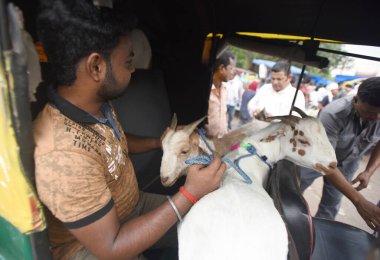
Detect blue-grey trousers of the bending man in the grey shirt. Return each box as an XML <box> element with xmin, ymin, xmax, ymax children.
<box><xmin>300</xmin><ymin>160</ymin><xmax>360</xmax><ymax>220</ymax></box>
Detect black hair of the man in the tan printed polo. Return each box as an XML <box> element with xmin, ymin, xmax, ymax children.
<box><xmin>37</xmin><ymin>0</ymin><xmax>133</xmax><ymax>85</ymax></box>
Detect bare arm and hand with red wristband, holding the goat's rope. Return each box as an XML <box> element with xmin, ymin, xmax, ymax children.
<box><xmin>70</xmin><ymin>156</ymin><xmax>226</xmax><ymax>259</ymax></box>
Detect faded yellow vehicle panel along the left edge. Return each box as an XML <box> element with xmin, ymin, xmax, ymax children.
<box><xmin>0</xmin><ymin>52</ymin><xmax>46</xmax><ymax>234</ymax></box>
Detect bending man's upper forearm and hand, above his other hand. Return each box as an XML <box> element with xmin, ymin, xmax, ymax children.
<box><xmin>352</xmin><ymin>142</ymin><xmax>380</xmax><ymax>191</ymax></box>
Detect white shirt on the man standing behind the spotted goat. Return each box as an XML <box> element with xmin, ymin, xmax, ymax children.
<box><xmin>248</xmin><ymin>84</ymin><xmax>305</xmax><ymax>116</ymax></box>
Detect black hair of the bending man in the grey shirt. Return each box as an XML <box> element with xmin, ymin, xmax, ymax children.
<box><xmin>357</xmin><ymin>77</ymin><xmax>380</xmax><ymax>107</ymax></box>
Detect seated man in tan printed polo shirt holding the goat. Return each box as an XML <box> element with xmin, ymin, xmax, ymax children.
<box><xmin>33</xmin><ymin>0</ymin><xmax>226</xmax><ymax>260</ymax></box>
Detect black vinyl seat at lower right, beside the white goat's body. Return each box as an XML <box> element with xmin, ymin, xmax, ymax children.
<box><xmin>267</xmin><ymin>160</ymin><xmax>375</xmax><ymax>260</ymax></box>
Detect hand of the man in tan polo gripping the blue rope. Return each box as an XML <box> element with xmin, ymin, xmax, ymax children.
<box><xmin>184</xmin><ymin>154</ymin><xmax>227</xmax><ymax>199</ymax></box>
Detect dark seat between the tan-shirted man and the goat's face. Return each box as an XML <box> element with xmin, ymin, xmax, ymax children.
<box><xmin>112</xmin><ymin>69</ymin><xmax>182</xmax><ymax>194</ymax></box>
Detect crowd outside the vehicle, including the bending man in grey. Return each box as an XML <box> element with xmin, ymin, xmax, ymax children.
<box><xmin>208</xmin><ymin>53</ymin><xmax>380</xmax><ymax>231</ymax></box>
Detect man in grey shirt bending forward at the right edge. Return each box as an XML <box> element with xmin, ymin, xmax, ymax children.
<box><xmin>300</xmin><ymin>77</ymin><xmax>380</xmax><ymax>228</ymax></box>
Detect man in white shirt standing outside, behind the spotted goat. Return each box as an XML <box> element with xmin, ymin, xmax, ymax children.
<box><xmin>248</xmin><ymin>61</ymin><xmax>305</xmax><ymax>117</ymax></box>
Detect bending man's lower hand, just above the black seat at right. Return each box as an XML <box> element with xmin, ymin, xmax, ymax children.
<box><xmin>355</xmin><ymin>197</ymin><xmax>380</xmax><ymax>231</ymax></box>
